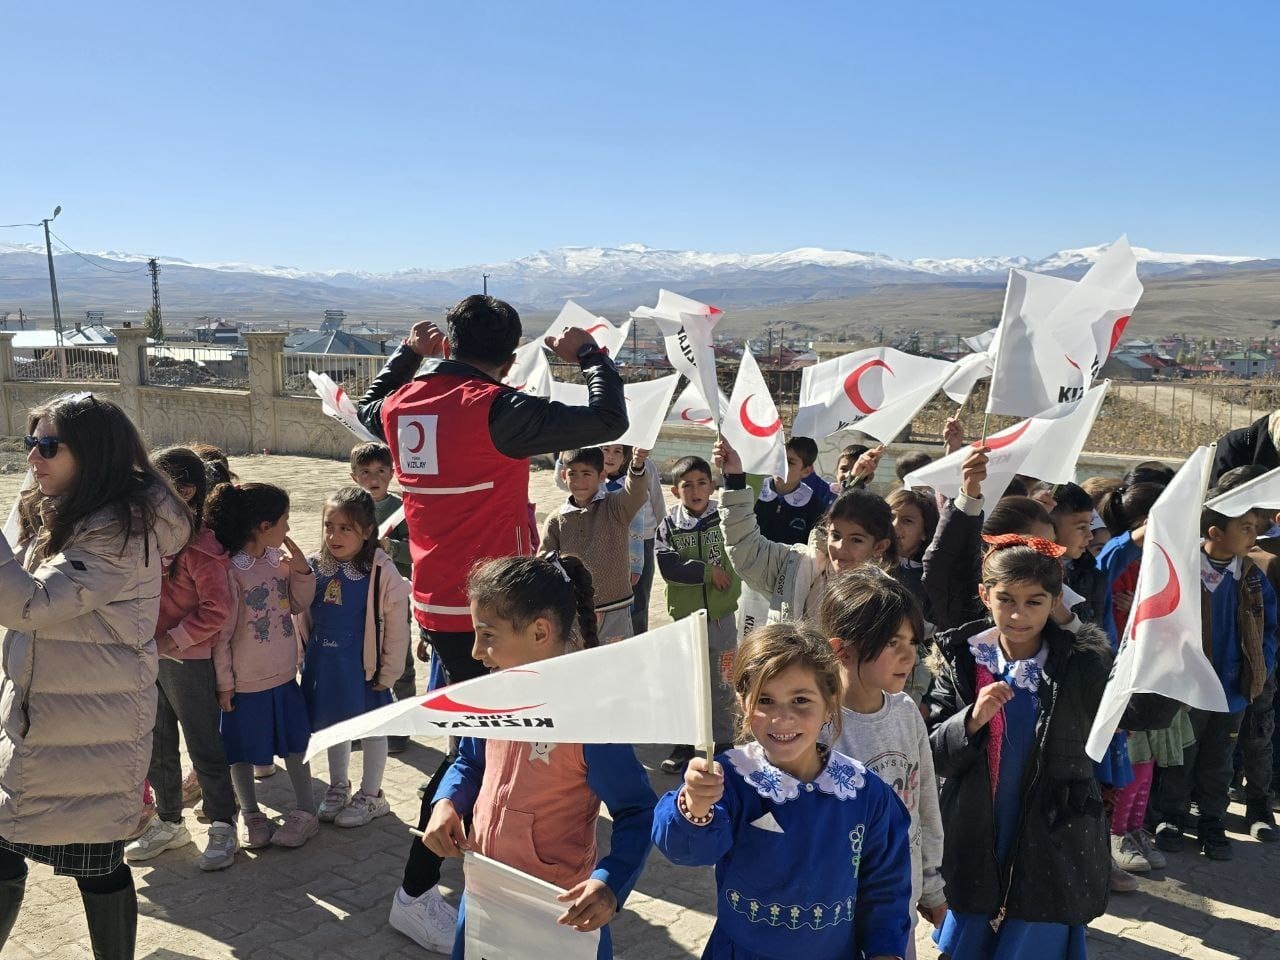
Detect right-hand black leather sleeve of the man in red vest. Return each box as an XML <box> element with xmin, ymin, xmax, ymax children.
<box><xmin>486</xmin><ymin>353</ymin><xmax>628</xmax><ymax>460</ymax></box>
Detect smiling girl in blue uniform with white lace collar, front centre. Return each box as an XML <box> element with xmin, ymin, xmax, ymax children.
<box><xmin>653</xmin><ymin>622</ymin><xmax>911</xmax><ymax>960</ymax></box>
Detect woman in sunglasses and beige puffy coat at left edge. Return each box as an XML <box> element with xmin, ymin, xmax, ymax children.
<box><xmin>0</xmin><ymin>393</ymin><xmax>193</xmax><ymax>960</ymax></box>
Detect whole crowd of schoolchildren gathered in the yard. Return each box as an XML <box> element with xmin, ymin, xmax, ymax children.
<box><xmin>102</xmin><ymin>424</ymin><xmax>1280</xmax><ymax>960</ymax></box>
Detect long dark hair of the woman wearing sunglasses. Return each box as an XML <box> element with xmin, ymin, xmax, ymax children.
<box><xmin>18</xmin><ymin>393</ymin><xmax>195</xmax><ymax>557</ymax></box>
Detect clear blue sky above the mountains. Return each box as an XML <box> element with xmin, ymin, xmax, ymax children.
<box><xmin>0</xmin><ymin>0</ymin><xmax>1280</xmax><ymax>270</ymax></box>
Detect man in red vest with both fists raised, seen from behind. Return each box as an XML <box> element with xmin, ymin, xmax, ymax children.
<box><xmin>358</xmin><ymin>296</ymin><xmax>627</xmax><ymax>954</ymax></box>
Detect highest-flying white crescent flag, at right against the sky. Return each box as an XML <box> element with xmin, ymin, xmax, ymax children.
<box><xmin>987</xmin><ymin>237</ymin><xmax>1142</xmax><ymax>416</ymax></box>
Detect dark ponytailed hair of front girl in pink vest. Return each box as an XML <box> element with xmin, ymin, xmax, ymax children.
<box><xmin>467</xmin><ymin>554</ymin><xmax>600</xmax><ymax>648</ymax></box>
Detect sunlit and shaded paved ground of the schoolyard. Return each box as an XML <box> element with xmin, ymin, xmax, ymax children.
<box><xmin>0</xmin><ymin>457</ymin><xmax>1280</xmax><ymax>960</ymax></box>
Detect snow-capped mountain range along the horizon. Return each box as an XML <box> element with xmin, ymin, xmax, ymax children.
<box><xmin>0</xmin><ymin>243</ymin><xmax>1265</xmax><ymax>312</ymax></box>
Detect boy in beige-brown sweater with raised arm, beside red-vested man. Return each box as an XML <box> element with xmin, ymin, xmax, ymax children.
<box><xmin>540</xmin><ymin>447</ymin><xmax>649</xmax><ymax>644</ymax></box>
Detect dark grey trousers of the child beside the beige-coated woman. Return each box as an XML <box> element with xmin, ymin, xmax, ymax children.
<box><xmin>147</xmin><ymin>658</ymin><xmax>236</xmax><ymax>823</ymax></box>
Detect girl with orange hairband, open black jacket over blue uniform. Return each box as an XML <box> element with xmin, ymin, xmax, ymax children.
<box><xmin>924</xmin><ymin>534</ymin><xmax>1111</xmax><ymax>960</ymax></box>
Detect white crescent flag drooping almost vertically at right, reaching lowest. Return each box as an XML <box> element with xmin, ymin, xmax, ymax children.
<box><xmin>1084</xmin><ymin>447</ymin><xmax>1226</xmax><ymax>760</ymax></box>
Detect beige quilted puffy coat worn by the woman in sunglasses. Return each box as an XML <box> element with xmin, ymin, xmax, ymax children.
<box><xmin>0</xmin><ymin>494</ymin><xmax>191</xmax><ymax>844</ymax></box>
